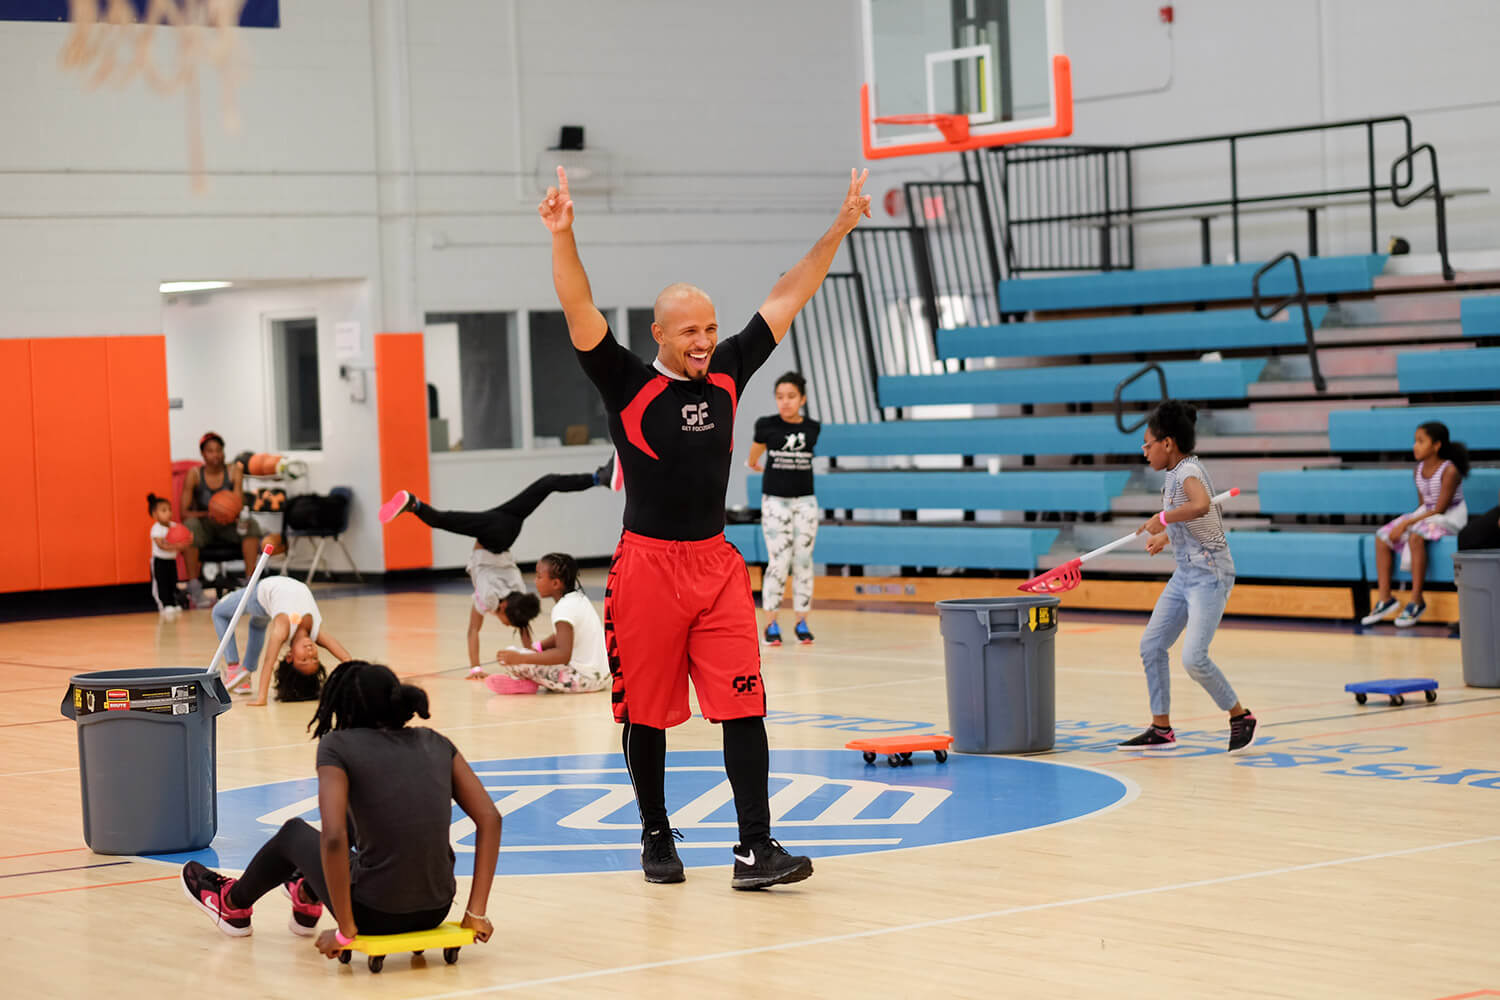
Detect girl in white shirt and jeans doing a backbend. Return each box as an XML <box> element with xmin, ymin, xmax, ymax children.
<box><xmin>213</xmin><ymin>576</ymin><xmax>350</xmax><ymax>705</ymax></box>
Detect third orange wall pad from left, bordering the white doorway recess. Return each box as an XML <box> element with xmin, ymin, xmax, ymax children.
<box><xmin>104</xmin><ymin>337</ymin><xmax>173</xmax><ymax>583</ymax></box>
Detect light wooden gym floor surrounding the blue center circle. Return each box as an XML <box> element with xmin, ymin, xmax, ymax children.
<box><xmin>0</xmin><ymin>574</ymin><xmax>1500</xmax><ymax>1000</ymax></box>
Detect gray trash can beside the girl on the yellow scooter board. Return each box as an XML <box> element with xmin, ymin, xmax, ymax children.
<box><xmin>62</xmin><ymin>667</ymin><xmax>230</xmax><ymax>855</ymax></box>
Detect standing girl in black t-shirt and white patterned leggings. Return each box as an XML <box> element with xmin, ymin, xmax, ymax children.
<box><xmin>746</xmin><ymin>372</ymin><xmax>821</xmax><ymax>646</ymax></box>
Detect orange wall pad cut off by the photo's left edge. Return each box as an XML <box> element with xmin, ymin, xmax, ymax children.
<box><xmin>0</xmin><ymin>340</ymin><xmax>42</xmax><ymax>592</ymax></box>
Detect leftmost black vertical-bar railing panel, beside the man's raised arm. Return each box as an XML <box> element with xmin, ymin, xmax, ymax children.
<box><xmin>791</xmin><ymin>274</ymin><xmax>884</xmax><ymax>423</ymax></box>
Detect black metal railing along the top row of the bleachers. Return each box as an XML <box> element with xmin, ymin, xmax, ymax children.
<box><xmin>978</xmin><ymin>115</ymin><xmax>1448</xmax><ymax>276</ymax></box>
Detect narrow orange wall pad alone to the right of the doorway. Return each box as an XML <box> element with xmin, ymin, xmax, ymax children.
<box><xmin>375</xmin><ymin>333</ymin><xmax>432</xmax><ymax>570</ymax></box>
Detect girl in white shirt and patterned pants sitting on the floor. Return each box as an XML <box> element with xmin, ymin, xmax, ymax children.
<box><xmin>495</xmin><ymin>552</ymin><xmax>609</xmax><ymax>694</ymax></box>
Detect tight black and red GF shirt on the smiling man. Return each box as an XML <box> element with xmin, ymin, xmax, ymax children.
<box><xmin>578</xmin><ymin>313</ymin><xmax>776</xmax><ymax>541</ymax></box>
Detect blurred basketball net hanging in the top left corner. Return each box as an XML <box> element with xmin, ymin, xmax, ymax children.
<box><xmin>62</xmin><ymin>0</ymin><xmax>246</xmax><ymax>192</ymax></box>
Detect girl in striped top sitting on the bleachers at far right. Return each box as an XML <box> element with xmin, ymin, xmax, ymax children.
<box><xmin>1361</xmin><ymin>420</ymin><xmax>1469</xmax><ymax>628</ymax></box>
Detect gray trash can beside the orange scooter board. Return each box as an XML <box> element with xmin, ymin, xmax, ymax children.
<box><xmin>938</xmin><ymin>597</ymin><xmax>1059</xmax><ymax>754</ymax></box>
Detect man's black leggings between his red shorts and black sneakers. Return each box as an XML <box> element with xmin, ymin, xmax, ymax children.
<box><xmin>620</xmin><ymin>717</ymin><xmax>771</xmax><ymax>844</ymax></box>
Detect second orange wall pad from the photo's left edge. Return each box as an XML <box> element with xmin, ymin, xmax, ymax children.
<box><xmin>32</xmin><ymin>337</ymin><xmax>117</xmax><ymax>589</ymax></box>
